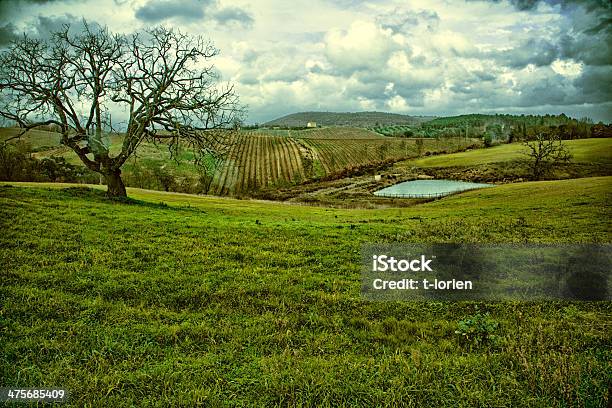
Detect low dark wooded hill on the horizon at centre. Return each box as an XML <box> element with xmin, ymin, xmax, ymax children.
<box><xmin>264</xmin><ymin>112</ymin><xmax>435</xmax><ymax>127</ymax></box>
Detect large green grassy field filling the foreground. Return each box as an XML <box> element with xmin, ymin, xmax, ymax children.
<box><xmin>0</xmin><ymin>177</ymin><xmax>612</xmax><ymax>407</ymax></box>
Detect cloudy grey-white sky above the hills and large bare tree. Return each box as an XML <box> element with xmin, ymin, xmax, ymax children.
<box><xmin>0</xmin><ymin>0</ymin><xmax>612</xmax><ymax>123</ymax></box>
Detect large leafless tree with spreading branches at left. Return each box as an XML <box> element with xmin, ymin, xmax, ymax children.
<box><xmin>0</xmin><ymin>21</ymin><xmax>243</xmax><ymax>197</ymax></box>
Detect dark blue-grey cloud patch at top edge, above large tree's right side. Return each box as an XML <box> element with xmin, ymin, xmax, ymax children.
<box><xmin>135</xmin><ymin>0</ymin><xmax>210</xmax><ymax>23</ymax></box>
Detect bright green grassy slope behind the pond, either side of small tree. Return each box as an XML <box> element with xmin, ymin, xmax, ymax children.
<box><xmin>406</xmin><ymin>138</ymin><xmax>612</xmax><ymax>167</ymax></box>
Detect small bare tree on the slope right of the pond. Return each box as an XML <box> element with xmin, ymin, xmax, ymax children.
<box><xmin>525</xmin><ymin>133</ymin><xmax>572</xmax><ymax>180</ymax></box>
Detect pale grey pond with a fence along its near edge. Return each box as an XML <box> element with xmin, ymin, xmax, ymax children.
<box><xmin>374</xmin><ymin>180</ymin><xmax>494</xmax><ymax>198</ymax></box>
